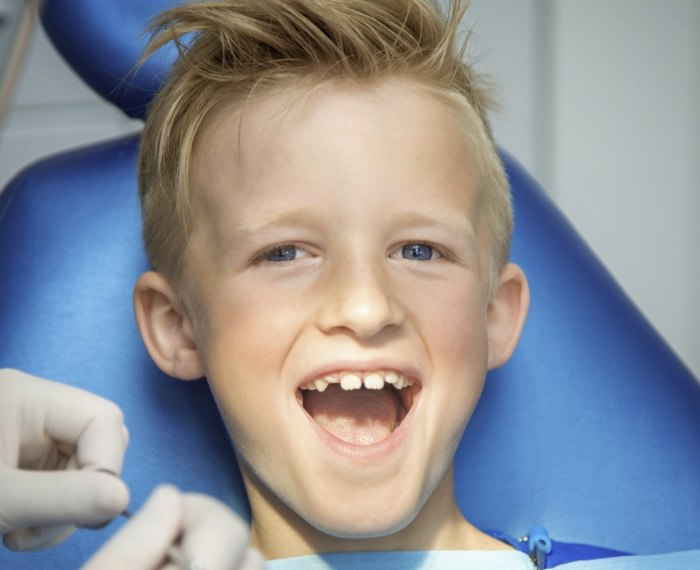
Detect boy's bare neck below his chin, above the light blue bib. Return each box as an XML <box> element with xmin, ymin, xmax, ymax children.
<box><xmin>248</xmin><ymin>470</ymin><xmax>510</xmax><ymax>560</ymax></box>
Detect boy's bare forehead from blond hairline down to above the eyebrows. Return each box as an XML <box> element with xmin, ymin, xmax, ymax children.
<box><xmin>189</xmin><ymin>80</ymin><xmax>486</xmax><ymax>235</ymax></box>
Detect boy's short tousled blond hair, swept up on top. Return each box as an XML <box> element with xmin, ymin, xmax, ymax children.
<box><xmin>139</xmin><ymin>0</ymin><xmax>512</xmax><ymax>285</ymax></box>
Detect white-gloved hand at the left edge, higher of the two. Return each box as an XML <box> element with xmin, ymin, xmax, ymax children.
<box><xmin>0</xmin><ymin>369</ymin><xmax>129</xmax><ymax>550</ymax></box>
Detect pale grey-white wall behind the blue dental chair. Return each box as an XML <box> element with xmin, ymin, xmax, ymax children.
<box><xmin>0</xmin><ymin>0</ymin><xmax>700</xmax><ymax>382</ymax></box>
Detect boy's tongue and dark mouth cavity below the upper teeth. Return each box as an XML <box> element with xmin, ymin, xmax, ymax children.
<box><xmin>304</xmin><ymin>384</ymin><xmax>399</xmax><ymax>445</ymax></box>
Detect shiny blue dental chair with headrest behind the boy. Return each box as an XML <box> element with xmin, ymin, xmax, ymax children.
<box><xmin>0</xmin><ymin>0</ymin><xmax>700</xmax><ymax>569</ymax></box>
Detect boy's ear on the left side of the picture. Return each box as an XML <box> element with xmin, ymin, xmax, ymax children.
<box><xmin>134</xmin><ymin>271</ymin><xmax>204</xmax><ymax>380</ymax></box>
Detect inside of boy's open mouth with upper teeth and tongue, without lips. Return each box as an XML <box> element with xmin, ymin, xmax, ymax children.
<box><xmin>298</xmin><ymin>370</ymin><xmax>420</xmax><ymax>445</ymax></box>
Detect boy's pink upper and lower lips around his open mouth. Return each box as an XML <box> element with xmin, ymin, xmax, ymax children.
<box><xmin>296</xmin><ymin>360</ymin><xmax>423</xmax><ymax>463</ymax></box>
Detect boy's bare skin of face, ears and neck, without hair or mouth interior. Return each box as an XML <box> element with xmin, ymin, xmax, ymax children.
<box><xmin>135</xmin><ymin>79</ymin><xmax>528</xmax><ymax>558</ymax></box>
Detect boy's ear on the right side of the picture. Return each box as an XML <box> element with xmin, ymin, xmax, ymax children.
<box><xmin>487</xmin><ymin>263</ymin><xmax>530</xmax><ymax>370</ymax></box>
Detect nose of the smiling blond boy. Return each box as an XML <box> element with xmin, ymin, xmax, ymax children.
<box><xmin>319</xmin><ymin>261</ymin><xmax>404</xmax><ymax>339</ymax></box>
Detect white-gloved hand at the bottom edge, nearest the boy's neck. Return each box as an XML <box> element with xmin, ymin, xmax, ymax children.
<box><xmin>83</xmin><ymin>486</ymin><xmax>264</xmax><ymax>570</ymax></box>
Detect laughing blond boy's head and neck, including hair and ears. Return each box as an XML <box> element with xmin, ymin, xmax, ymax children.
<box><xmin>130</xmin><ymin>0</ymin><xmax>612</xmax><ymax>560</ymax></box>
